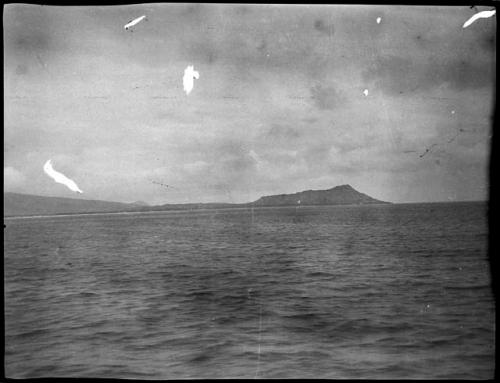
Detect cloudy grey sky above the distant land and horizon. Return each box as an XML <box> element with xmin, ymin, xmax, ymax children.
<box><xmin>4</xmin><ymin>4</ymin><xmax>496</xmax><ymax>204</ymax></box>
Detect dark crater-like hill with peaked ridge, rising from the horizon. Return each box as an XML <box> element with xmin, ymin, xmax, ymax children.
<box><xmin>253</xmin><ymin>185</ymin><xmax>389</xmax><ymax>206</ymax></box>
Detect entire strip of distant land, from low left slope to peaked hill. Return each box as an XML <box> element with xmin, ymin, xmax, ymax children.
<box><xmin>4</xmin><ymin>185</ymin><xmax>390</xmax><ymax>217</ymax></box>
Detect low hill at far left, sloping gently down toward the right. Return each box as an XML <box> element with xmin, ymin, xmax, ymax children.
<box><xmin>3</xmin><ymin>193</ymin><xmax>138</xmax><ymax>217</ymax></box>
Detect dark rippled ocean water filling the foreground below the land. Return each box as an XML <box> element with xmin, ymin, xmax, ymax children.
<box><xmin>4</xmin><ymin>203</ymin><xmax>495</xmax><ymax>379</ymax></box>
